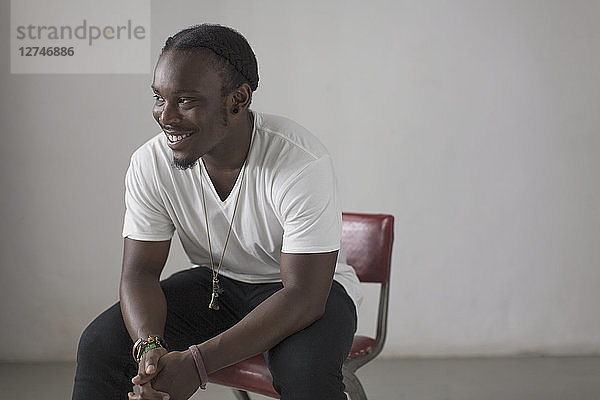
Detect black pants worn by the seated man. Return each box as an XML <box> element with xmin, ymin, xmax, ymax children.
<box><xmin>73</xmin><ymin>267</ymin><xmax>356</xmax><ymax>400</ymax></box>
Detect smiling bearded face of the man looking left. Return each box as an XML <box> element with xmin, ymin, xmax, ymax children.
<box><xmin>152</xmin><ymin>51</ymin><xmax>228</xmax><ymax>169</ymax></box>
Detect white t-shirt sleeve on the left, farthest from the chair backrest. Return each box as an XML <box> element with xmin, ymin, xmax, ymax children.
<box><xmin>123</xmin><ymin>153</ymin><xmax>175</xmax><ymax>241</ymax></box>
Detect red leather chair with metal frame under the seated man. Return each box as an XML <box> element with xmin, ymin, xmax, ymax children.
<box><xmin>208</xmin><ymin>213</ymin><xmax>394</xmax><ymax>400</ymax></box>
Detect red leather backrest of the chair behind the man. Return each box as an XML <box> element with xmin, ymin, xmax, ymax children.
<box><xmin>342</xmin><ymin>213</ymin><xmax>394</xmax><ymax>283</ymax></box>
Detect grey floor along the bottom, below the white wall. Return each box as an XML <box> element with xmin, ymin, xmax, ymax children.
<box><xmin>0</xmin><ymin>357</ymin><xmax>600</xmax><ymax>400</ymax></box>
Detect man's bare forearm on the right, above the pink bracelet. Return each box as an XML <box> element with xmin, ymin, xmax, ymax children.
<box><xmin>198</xmin><ymin>288</ymin><xmax>324</xmax><ymax>373</ymax></box>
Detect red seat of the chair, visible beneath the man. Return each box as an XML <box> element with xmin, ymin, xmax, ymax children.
<box><xmin>208</xmin><ymin>335</ymin><xmax>377</xmax><ymax>398</ymax></box>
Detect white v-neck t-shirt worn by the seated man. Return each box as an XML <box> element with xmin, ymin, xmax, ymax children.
<box><xmin>123</xmin><ymin>112</ymin><xmax>361</xmax><ymax>306</ymax></box>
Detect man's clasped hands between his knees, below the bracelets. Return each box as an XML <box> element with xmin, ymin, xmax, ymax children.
<box><xmin>128</xmin><ymin>348</ymin><xmax>200</xmax><ymax>400</ymax></box>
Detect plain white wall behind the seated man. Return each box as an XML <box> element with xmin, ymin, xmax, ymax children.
<box><xmin>0</xmin><ymin>0</ymin><xmax>600</xmax><ymax>360</ymax></box>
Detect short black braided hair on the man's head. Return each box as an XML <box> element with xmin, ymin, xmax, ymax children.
<box><xmin>161</xmin><ymin>24</ymin><xmax>258</xmax><ymax>95</ymax></box>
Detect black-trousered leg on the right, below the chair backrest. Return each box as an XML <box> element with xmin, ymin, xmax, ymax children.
<box><xmin>265</xmin><ymin>281</ymin><xmax>356</xmax><ymax>399</ymax></box>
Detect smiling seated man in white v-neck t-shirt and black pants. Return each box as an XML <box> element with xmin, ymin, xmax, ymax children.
<box><xmin>73</xmin><ymin>24</ymin><xmax>360</xmax><ymax>400</ymax></box>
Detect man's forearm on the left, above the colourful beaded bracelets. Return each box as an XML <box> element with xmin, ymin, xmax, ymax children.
<box><xmin>120</xmin><ymin>273</ymin><xmax>167</xmax><ymax>341</ymax></box>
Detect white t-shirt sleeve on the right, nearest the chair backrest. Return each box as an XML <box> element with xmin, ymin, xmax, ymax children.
<box><xmin>280</xmin><ymin>156</ymin><xmax>342</xmax><ymax>253</ymax></box>
